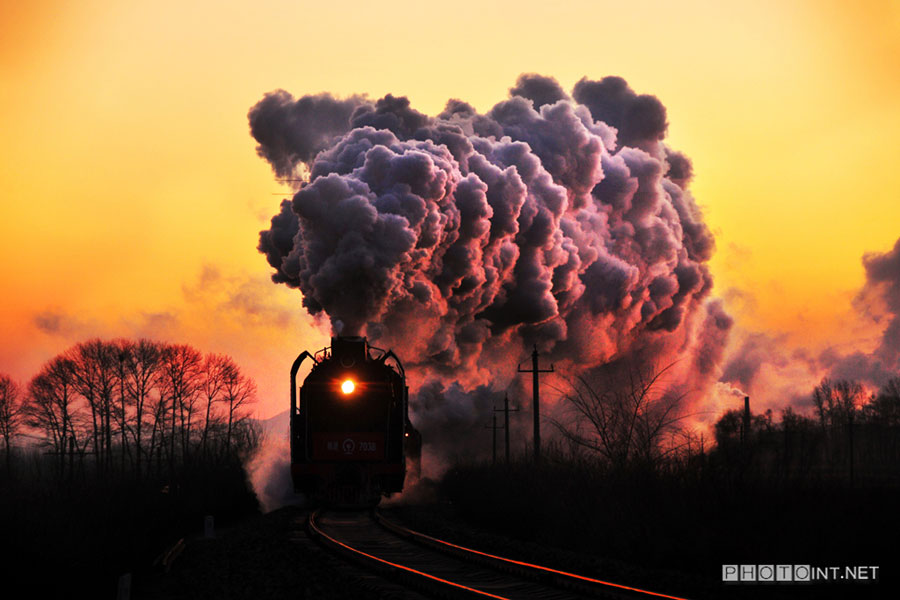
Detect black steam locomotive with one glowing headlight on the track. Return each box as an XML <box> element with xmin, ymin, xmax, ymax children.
<box><xmin>290</xmin><ymin>336</ymin><xmax>422</xmax><ymax>507</ymax></box>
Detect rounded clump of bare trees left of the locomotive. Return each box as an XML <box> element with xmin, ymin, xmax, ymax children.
<box><xmin>9</xmin><ymin>339</ymin><xmax>256</xmax><ymax>480</ymax></box>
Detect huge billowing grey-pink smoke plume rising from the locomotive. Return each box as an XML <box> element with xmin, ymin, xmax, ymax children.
<box><xmin>249</xmin><ymin>75</ymin><xmax>731</xmax><ymax>462</ymax></box>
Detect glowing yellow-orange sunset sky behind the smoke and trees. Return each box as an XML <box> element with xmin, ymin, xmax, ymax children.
<box><xmin>0</xmin><ymin>0</ymin><xmax>900</xmax><ymax>417</ymax></box>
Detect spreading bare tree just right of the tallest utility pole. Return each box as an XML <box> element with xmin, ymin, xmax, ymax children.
<box><xmin>555</xmin><ymin>355</ymin><xmax>686</xmax><ymax>467</ymax></box>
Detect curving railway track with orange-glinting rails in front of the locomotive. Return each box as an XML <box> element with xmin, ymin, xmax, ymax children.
<box><xmin>307</xmin><ymin>511</ymin><xmax>684</xmax><ymax>600</ymax></box>
